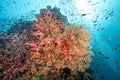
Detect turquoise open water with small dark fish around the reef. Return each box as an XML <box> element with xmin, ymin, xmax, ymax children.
<box><xmin>0</xmin><ymin>0</ymin><xmax>120</xmax><ymax>80</ymax></box>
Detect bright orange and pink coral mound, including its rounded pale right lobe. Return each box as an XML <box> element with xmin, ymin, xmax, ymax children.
<box><xmin>26</xmin><ymin>7</ymin><xmax>92</xmax><ymax>79</ymax></box>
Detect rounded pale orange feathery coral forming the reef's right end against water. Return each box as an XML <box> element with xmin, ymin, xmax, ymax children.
<box><xmin>55</xmin><ymin>25</ymin><xmax>92</xmax><ymax>73</ymax></box>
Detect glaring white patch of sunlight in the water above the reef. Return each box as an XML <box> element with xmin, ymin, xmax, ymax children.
<box><xmin>75</xmin><ymin>0</ymin><xmax>96</xmax><ymax>21</ymax></box>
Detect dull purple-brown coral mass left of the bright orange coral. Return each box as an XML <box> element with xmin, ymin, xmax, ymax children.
<box><xmin>0</xmin><ymin>21</ymin><xmax>33</xmax><ymax>80</ymax></box>
